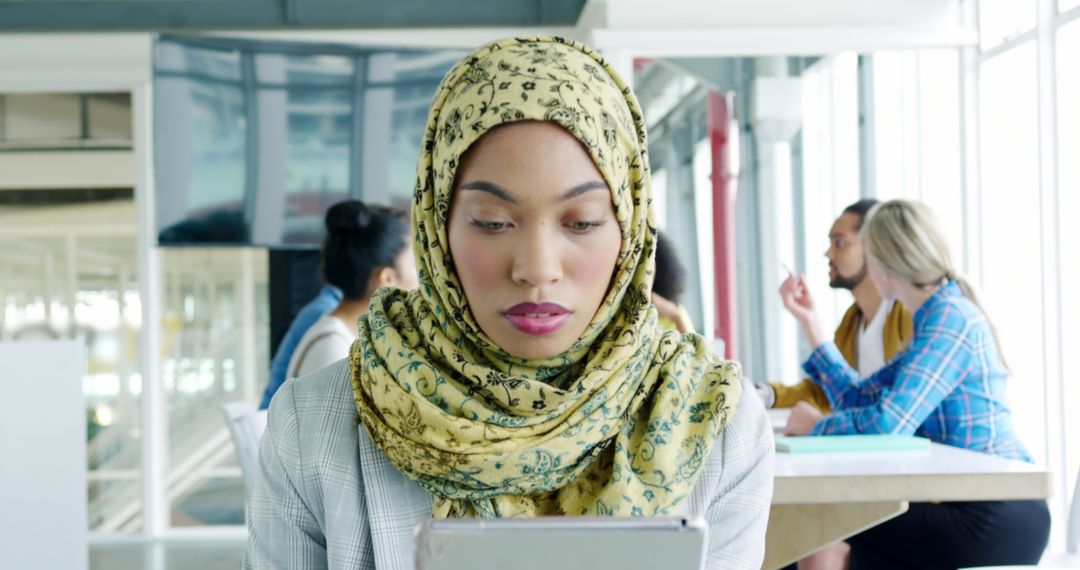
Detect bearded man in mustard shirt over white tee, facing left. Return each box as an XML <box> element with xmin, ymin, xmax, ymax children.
<box><xmin>758</xmin><ymin>199</ymin><xmax>912</xmax><ymax>413</ymax></box>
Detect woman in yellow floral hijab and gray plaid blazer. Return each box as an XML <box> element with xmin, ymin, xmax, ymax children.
<box><xmin>244</xmin><ymin>37</ymin><xmax>772</xmax><ymax>569</ymax></box>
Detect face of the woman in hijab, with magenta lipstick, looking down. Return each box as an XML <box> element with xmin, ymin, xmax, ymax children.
<box><xmin>449</xmin><ymin>122</ymin><xmax>622</xmax><ymax>358</ymax></box>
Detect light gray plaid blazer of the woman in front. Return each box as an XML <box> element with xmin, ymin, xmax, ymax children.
<box><xmin>244</xmin><ymin>361</ymin><xmax>773</xmax><ymax>570</ymax></box>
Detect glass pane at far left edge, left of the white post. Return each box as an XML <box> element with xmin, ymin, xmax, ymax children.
<box><xmin>0</xmin><ymin>86</ymin><xmax>143</xmax><ymax>531</ymax></box>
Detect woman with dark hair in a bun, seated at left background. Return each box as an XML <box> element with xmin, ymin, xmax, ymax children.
<box><xmin>285</xmin><ymin>200</ymin><xmax>418</xmax><ymax>378</ymax></box>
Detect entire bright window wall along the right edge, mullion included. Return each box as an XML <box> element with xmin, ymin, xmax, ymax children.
<box><xmin>969</xmin><ymin>0</ymin><xmax>1080</xmax><ymax>551</ymax></box>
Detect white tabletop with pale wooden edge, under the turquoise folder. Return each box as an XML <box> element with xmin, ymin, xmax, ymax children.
<box><xmin>772</xmin><ymin>444</ymin><xmax>1051</xmax><ymax>504</ymax></box>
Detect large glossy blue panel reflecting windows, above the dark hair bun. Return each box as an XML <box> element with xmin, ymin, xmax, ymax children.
<box><xmin>154</xmin><ymin>38</ymin><xmax>460</xmax><ymax>248</ymax></box>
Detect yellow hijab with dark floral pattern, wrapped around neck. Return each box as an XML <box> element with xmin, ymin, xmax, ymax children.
<box><xmin>350</xmin><ymin>36</ymin><xmax>741</xmax><ymax>517</ymax></box>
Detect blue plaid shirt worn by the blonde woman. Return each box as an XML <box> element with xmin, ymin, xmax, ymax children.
<box><xmin>802</xmin><ymin>281</ymin><xmax>1031</xmax><ymax>461</ymax></box>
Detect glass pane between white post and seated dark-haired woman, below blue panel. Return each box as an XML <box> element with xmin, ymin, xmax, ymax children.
<box><xmin>161</xmin><ymin>248</ymin><xmax>270</xmax><ymax>527</ymax></box>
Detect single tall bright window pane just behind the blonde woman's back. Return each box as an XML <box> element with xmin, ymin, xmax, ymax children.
<box><xmin>978</xmin><ymin>41</ymin><xmax>1047</xmax><ymax>462</ymax></box>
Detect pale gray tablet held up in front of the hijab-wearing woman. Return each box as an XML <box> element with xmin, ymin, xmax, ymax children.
<box><xmin>415</xmin><ymin>517</ymin><xmax>708</xmax><ymax>570</ymax></box>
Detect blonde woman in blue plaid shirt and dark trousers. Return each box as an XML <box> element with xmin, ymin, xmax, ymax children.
<box><xmin>781</xmin><ymin>200</ymin><xmax>1050</xmax><ymax>569</ymax></box>
